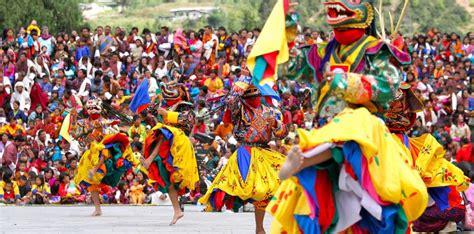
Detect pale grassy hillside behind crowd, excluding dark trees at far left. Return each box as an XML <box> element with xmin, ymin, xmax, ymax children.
<box><xmin>83</xmin><ymin>0</ymin><xmax>474</xmax><ymax>34</ymax></box>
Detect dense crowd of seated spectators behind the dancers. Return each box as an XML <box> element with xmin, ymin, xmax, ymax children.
<box><xmin>0</xmin><ymin>21</ymin><xmax>474</xmax><ymax>207</ymax></box>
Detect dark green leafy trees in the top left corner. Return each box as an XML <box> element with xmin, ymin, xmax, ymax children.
<box><xmin>0</xmin><ymin>0</ymin><xmax>83</xmax><ymax>33</ymax></box>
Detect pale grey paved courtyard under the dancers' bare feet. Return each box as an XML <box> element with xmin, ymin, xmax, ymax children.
<box><xmin>0</xmin><ymin>206</ymin><xmax>271</xmax><ymax>234</ymax></box>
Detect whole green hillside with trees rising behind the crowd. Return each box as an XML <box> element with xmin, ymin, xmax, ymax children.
<box><xmin>0</xmin><ymin>0</ymin><xmax>474</xmax><ymax>34</ymax></box>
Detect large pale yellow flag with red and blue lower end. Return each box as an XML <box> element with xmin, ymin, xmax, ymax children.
<box><xmin>247</xmin><ymin>0</ymin><xmax>289</xmax><ymax>100</ymax></box>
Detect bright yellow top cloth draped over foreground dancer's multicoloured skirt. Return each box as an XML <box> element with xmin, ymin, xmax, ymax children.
<box><xmin>298</xmin><ymin>108</ymin><xmax>428</xmax><ymax>221</ymax></box>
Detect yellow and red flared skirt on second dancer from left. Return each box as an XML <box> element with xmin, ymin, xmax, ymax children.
<box><xmin>144</xmin><ymin>124</ymin><xmax>199</xmax><ymax>194</ymax></box>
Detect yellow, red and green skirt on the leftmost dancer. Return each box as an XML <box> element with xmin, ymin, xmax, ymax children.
<box><xmin>74</xmin><ymin>133</ymin><xmax>140</xmax><ymax>191</ymax></box>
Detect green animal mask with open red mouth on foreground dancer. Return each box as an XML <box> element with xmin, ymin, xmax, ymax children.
<box><xmin>324</xmin><ymin>0</ymin><xmax>374</xmax><ymax>29</ymax></box>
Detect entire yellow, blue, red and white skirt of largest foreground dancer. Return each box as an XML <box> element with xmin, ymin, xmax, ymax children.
<box><xmin>267</xmin><ymin>108</ymin><xmax>428</xmax><ymax>233</ymax></box>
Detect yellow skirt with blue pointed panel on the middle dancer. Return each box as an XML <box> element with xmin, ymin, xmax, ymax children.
<box><xmin>199</xmin><ymin>146</ymin><xmax>285</xmax><ymax>211</ymax></box>
